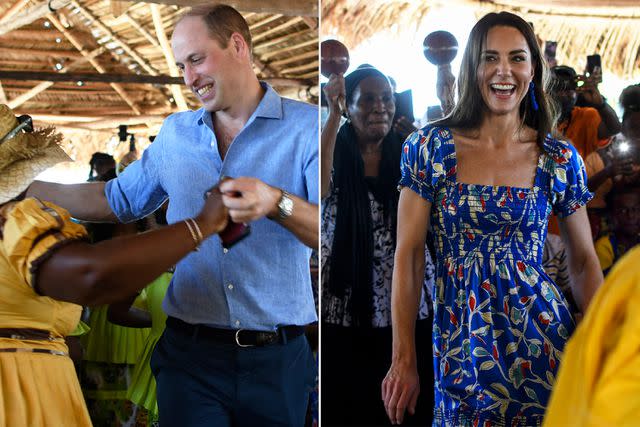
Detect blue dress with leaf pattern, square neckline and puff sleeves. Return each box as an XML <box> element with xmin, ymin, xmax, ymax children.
<box><xmin>400</xmin><ymin>126</ymin><xmax>591</xmax><ymax>427</ymax></box>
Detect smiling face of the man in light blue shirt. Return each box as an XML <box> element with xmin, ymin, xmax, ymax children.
<box><xmin>171</xmin><ymin>17</ymin><xmax>238</xmax><ymax>112</ymax></box>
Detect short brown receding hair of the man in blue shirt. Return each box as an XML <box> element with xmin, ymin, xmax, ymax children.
<box><xmin>180</xmin><ymin>4</ymin><xmax>253</xmax><ymax>56</ymax></box>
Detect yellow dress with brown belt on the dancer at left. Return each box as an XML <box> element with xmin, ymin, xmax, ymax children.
<box><xmin>0</xmin><ymin>199</ymin><xmax>91</xmax><ymax>427</ymax></box>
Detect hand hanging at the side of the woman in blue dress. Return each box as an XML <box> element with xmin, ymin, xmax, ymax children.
<box><xmin>382</xmin><ymin>362</ymin><xmax>420</xmax><ymax>424</ymax></box>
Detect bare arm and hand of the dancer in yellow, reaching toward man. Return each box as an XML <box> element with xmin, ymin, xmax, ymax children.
<box><xmin>34</xmin><ymin>190</ymin><xmax>228</xmax><ymax>306</ymax></box>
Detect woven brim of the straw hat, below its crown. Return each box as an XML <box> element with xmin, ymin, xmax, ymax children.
<box><xmin>0</xmin><ymin>145</ymin><xmax>72</xmax><ymax>204</ymax></box>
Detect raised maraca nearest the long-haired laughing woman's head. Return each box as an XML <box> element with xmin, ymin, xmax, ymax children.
<box><xmin>422</xmin><ymin>31</ymin><xmax>458</xmax><ymax>115</ymax></box>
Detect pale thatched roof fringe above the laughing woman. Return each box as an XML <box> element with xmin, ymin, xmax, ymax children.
<box><xmin>321</xmin><ymin>0</ymin><xmax>640</xmax><ymax>81</ymax></box>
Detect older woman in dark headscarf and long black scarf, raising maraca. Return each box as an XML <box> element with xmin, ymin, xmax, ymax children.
<box><xmin>320</xmin><ymin>67</ymin><xmax>433</xmax><ymax>425</ymax></box>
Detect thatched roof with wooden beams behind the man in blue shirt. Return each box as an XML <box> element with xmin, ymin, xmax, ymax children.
<box><xmin>0</xmin><ymin>0</ymin><xmax>318</xmax><ymax>133</ymax></box>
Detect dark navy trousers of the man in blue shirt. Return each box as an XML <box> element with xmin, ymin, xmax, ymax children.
<box><xmin>151</xmin><ymin>320</ymin><xmax>316</xmax><ymax>427</ymax></box>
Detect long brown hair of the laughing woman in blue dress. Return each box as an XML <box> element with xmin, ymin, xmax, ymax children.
<box><xmin>434</xmin><ymin>12</ymin><xmax>557</xmax><ymax>148</ymax></box>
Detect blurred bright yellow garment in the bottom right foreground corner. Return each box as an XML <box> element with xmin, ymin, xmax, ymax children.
<box><xmin>544</xmin><ymin>246</ymin><xmax>640</xmax><ymax>427</ymax></box>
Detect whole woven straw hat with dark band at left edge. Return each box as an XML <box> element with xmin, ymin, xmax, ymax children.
<box><xmin>0</xmin><ymin>104</ymin><xmax>71</xmax><ymax>204</ymax></box>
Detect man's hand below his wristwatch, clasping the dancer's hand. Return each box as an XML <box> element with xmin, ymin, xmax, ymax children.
<box><xmin>219</xmin><ymin>177</ymin><xmax>282</xmax><ymax>222</ymax></box>
